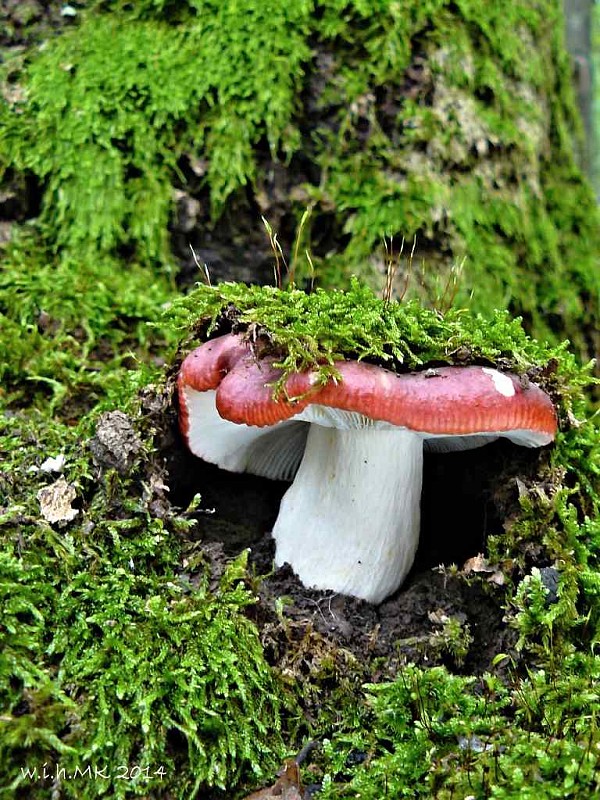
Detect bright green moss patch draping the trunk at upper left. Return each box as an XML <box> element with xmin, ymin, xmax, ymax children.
<box><xmin>0</xmin><ymin>0</ymin><xmax>309</xmax><ymax>262</ymax></box>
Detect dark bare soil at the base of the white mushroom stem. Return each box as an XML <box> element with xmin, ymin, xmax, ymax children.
<box><xmin>258</xmin><ymin>560</ymin><xmax>514</xmax><ymax>678</ymax></box>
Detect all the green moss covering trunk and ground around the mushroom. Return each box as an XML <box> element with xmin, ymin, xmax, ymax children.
<box><xmin>0</xmin><ymin>0</ymin><xmax>600</xmax><ymax>800</ymax></box>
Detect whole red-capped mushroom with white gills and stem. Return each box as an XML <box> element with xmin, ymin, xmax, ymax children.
<box><xmin>178</xmin><ymin>334</ymin><xmax>557</xmax><ymax>603</ymax></box>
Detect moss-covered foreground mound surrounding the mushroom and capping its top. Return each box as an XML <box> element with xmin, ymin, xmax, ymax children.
<box><xmin>0</xmin><ymin>283</ymin><xmax>600</xmax><ymax>798</ymax></box>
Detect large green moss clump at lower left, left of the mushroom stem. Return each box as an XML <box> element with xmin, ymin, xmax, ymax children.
<box><xmin>0</xmin><ymin>414</ymin><xmax>291</xmax><ymax>798</ymax></box>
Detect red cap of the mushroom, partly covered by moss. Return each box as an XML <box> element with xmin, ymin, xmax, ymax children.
<box><xmin>179</xmin><ymin>334</ymin><xmax>557</xmax><ymax>454</ymax></box>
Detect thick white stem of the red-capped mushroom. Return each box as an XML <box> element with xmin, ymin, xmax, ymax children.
<box><xmin>273</xmin><ymin>424</ymin><xmax>423</xmax><ymax>603</ymax></box>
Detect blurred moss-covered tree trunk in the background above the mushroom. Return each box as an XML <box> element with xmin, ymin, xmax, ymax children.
<box><xmin>0</xmin><ymin>0</ymin><xmax>600</xmax><ymax>357</ymax></box>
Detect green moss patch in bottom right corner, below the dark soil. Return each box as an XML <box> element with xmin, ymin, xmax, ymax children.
<box><xmin>316</xmin><ymin>656</ymin><xmax>600</xmax><ymax>800</ymax></box>
